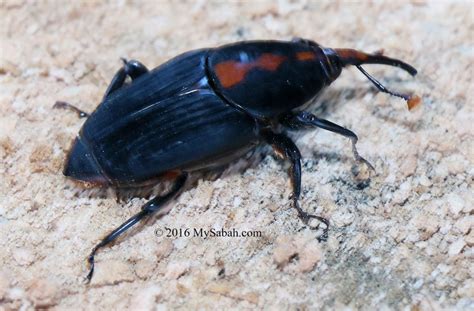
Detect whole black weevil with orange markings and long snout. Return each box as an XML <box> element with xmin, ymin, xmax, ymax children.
<box><xmin>55</xmin><ymin>38</ymin><xmax>420</xmax><ymax>281</ymax></box>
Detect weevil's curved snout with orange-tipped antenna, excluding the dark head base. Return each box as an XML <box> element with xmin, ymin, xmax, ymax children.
<box><xmin>334</xmin><ymin>49</ymin><xmax>421</xmax><ymax>109</ymax></box>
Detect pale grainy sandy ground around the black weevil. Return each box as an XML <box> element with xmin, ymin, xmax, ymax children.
<box><xmin>0</xmin><ymin>1</ymin><xmax>474</xmax><ymax>310</ymax></box>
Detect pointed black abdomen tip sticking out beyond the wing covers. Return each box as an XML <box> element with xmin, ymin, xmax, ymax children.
<box><xmin>63</xmin><ymin>137</ymin><xmax>107</xmax><ymax>184</ymax></box>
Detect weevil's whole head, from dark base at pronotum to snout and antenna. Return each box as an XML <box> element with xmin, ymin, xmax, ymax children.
<box><xmin>322</xmin><ymin>48</ymin><xmax>421</xmax><ymax>109</ymax></box>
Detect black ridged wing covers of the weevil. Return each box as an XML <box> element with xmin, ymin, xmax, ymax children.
<box><xmin>77</xmin><ymin>50</ymin><xmax>258</xmax><ymax>185</ymax></box>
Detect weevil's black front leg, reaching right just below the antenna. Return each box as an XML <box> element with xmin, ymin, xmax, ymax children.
<box><xmin>281</xmin><ymin>111</ymin><xmax>375</xmax><ymax>171</ymax></box>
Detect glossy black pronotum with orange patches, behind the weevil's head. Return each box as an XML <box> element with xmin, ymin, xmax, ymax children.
<box><xmin>208</xmin><ymin>41</ymin><xmax>334</xmax><ymax>117</ymax></box>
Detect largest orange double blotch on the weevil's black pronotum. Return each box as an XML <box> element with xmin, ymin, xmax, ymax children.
<box><xmin>214</xmin><ymin>53</ymin><xmax>286</xmax><ymax>88</ymax></box>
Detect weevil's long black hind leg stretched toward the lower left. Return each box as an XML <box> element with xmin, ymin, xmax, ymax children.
<box><xmin>86</xmin><ymin>173</ymin><xmax>188</xmax><ymax>283</ymax></box>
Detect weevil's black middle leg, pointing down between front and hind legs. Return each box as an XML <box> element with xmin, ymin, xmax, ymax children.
<box><xmin>262</xmin><ymin>131</ymin><xmax>329</xmax><ymax>241</ymax></box>
